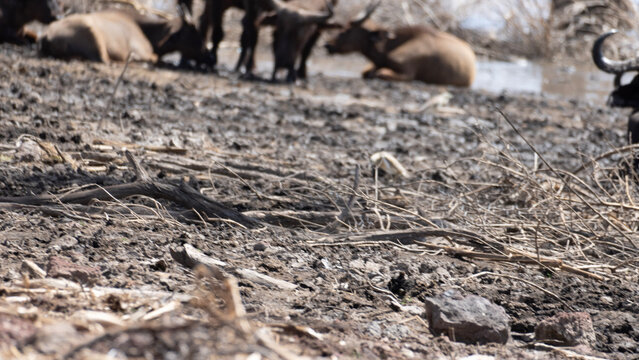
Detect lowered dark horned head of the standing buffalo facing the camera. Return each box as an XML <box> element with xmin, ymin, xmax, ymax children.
<box><xmin>266</xmin><ymin>0</ymin><xmax>333</xmax><ymax>67</ymax></box>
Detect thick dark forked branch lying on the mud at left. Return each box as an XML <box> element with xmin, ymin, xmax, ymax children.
<box><xmin>0</xmin><ymin>150</ymin><xmax>258</xmax><ymax>228</ymax></box>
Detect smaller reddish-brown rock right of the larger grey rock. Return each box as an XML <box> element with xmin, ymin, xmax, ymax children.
<box><xmin>535</xmin><ymin>312</ymin><xmax>596</xmax><ymax>346</ymax></box>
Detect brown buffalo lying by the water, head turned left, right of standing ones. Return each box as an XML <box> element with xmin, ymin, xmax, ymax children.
<box><xmin>326</xmin><ymin>2</ymin><xmax>475</xmax><ymax>87</ymax></box>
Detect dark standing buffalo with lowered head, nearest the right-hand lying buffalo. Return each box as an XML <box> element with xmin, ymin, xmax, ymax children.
<box><xmin>266</xmin><ymin>0</ymin><xmax>337</xmax><ymax>82</ymax></box>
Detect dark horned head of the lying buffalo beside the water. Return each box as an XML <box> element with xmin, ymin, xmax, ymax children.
<box><xmin>325</xmin><ymin>1</ymin><xmax>389</xmax><ymax>54</ymax></box>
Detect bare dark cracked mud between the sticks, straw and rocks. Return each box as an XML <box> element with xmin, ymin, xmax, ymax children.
<box><xmin>0</xmin><ymin>39</ymin><xmax>639</xmax><ymax>359</ymax></box>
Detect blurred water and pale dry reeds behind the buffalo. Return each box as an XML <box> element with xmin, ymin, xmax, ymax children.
<box><xmin>58</xmin><ymin>0</ymin><xmax>639</xmax><ymax>103</ymax></box>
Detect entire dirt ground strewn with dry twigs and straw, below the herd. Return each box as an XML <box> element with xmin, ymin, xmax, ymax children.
<box><xmin>0</xmin><ymin>37</ymin><xmax>639</xmax><ymax>359</ymax></box>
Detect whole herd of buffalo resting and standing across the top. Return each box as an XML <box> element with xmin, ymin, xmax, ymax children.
<box><xmin>0</xmin><ymin>0</ymin><xmax>639</xmax><ymax>144</ymax></box>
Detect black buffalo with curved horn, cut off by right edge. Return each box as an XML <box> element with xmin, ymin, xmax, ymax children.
<box><xmin>592</xmin><ymin>30</ymin><xmax>639</xmax><ymax>144</ymax></box>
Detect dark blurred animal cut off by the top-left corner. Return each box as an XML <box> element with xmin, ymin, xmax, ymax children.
<box><xmin>0</xmin><ymin>0</ymin><xmax>62</xmax><ymax>43</ymax></box>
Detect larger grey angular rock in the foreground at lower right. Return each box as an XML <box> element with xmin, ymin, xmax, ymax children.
<box><xmin>424</xmin><ymin>290</ymin><xmax>510</xmax><ymax>344</ymax></box>
